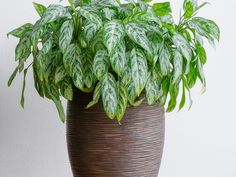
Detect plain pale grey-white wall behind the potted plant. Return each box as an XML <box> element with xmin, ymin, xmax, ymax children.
<box><xmin>0</xmin><ymin>0</ymin><xmax>236</xmax><ymax>177</ymax></box>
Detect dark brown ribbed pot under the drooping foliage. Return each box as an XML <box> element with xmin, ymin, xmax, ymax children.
<box><xmin>67</xmin><ymin>90</ymin><xmax>165</xmax><ymax>177</ymax></box>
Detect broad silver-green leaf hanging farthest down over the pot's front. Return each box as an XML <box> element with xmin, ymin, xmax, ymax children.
<box><xmin>102</xmin><ymin>73</ymin><xmax>118</xmax><ymax>119</ymax></box>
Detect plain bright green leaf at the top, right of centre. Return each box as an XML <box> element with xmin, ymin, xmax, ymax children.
<box><xmin>152</xmin><ymin>2</ymin><xmax>172</xmax><ymax>16</ymax></box>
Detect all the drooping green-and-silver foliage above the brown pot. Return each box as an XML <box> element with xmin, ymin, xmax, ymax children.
<box><xmin>8</xmin><ymin>0</ymin><xmax>220</xmax><ymax>122</ymax></box>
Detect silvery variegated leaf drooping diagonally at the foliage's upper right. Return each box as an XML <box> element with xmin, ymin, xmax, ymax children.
<box><xmin>172</xmin><ymin>32</ymin><xmax>193</xmax><ymax>73</ymax></box>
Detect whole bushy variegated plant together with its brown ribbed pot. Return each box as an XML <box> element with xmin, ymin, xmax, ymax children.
<box><xmin>8</xmin><ymin>0</ymin><xmax>220</xmax><ymax>177</ymax></box>
